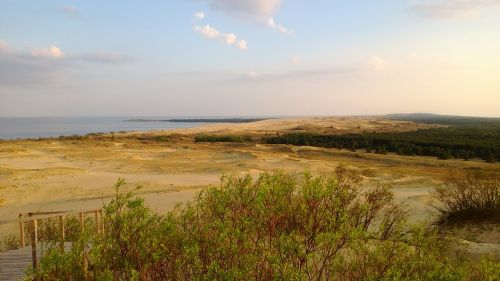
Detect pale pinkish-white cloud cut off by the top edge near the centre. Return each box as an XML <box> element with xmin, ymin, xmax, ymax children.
<box><xmin>205</xmin><ymin>0</ymin><xmax>282</xmax><ymax>17</ymax></box>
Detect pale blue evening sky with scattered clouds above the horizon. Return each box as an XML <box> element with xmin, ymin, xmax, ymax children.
<box><xmin>0</xmin><ymin>0</ymin><xmax>500</xmax><ymax>117</ymax></box>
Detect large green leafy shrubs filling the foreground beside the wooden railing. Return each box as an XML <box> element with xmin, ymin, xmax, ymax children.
<box><xmin>30</xmin><ymin>167</ymin><xmax>499</xmax><ymax>281</ymax></box>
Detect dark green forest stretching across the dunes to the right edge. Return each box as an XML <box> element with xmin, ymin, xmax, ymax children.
<box><xmin>263</xmin><ymin>123</ymin><xmax>500</xmax><ymax>163</ymax></box>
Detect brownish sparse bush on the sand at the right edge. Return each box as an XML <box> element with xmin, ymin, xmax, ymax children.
<box><xmin>435</xmin><ymin>167</ymin><xmax>500</xmax><ymax>222</ymax></box>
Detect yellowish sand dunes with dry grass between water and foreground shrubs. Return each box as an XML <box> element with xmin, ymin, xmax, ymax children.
<box><xmin>0</xmin><ymin>117</ymin><xmax>500</xmax><ymax>258</ymax></box>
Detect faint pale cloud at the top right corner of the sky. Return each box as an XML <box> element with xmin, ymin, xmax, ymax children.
<box><xmin>410</xmin><ymin>0</ymin><xmax>500</xmax><ymax>19</ymax></box>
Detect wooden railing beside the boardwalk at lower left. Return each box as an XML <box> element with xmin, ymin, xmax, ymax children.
<box><xmin>19</xmin><ymin>209</ymin><xmax>104</xmax><ymax>270</ymax></box>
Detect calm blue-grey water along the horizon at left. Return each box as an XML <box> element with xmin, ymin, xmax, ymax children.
<box><xmin>0</xmin><ymin>117</ymin><xmax>212</xmax><ymax>139</ymax></box>
